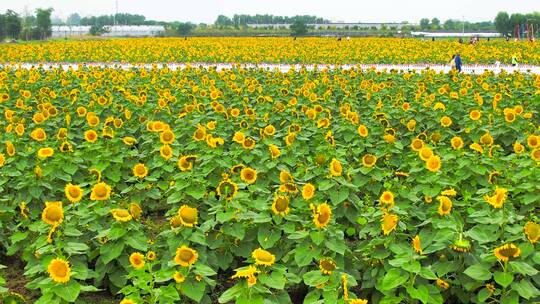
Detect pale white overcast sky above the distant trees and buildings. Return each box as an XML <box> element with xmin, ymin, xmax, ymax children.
<box><xmin>0</xmin><ymin>0</ymin><xmax>540</xmax><ymax>23</ymax></box>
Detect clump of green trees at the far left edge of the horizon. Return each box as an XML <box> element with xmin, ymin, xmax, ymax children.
<box><xmin>0</xmin><ymin>8</ymin><xmax>53</xmax><ymax>41</ymax></box>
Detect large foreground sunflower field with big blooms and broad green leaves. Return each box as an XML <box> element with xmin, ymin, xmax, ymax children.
<box><xmin>0</xmin><ymin>58</ymin><xmax>540</xmax><ymax>304</ymax></box>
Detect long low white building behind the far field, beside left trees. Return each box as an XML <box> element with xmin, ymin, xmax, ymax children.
<box><xmin>52</xmin><ymin>25</ymin><xmax>165</xmax><ymax>38</ymax></box>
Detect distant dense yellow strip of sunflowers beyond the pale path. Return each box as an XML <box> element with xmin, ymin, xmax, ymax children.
<box><xmin>0</xmin><ymin>37</ymin><xmax>540</xmax><ymax>65</ymax></box>
